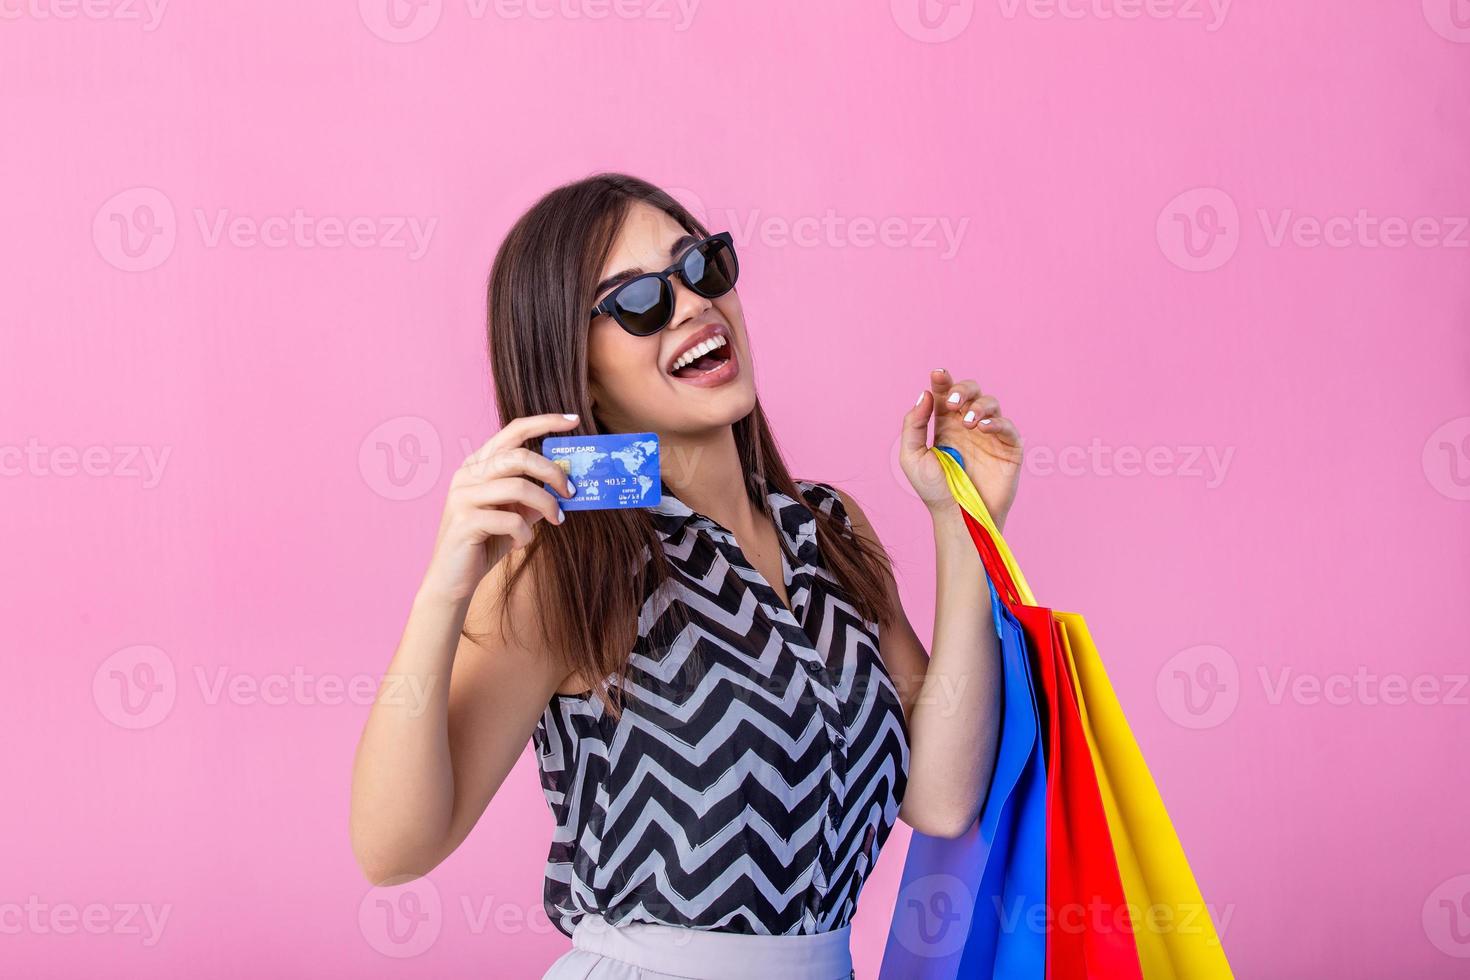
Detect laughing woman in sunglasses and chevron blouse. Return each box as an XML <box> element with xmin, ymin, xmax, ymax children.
<box><xmin>351</xmin><ymin>173</ymin><xmax>1022</xmax><ymax>980</ymax></box>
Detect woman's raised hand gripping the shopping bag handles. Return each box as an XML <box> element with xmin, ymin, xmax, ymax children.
<box><xmin>898</xmin><ymin>367</ymin><xmax>1023</xmax><ymax>527</ymax></box>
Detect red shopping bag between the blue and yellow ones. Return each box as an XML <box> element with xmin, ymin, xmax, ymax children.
<box><xmin>935</xmin><ymin>447</ymin><xmax>1142</xmax><ymax>980</ymax></box>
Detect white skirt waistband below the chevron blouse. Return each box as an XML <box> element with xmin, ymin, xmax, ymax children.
<box><xmin>542</xmin><ymin>915</ymin><xmax>854</xmax><ymax>980</ymax></box>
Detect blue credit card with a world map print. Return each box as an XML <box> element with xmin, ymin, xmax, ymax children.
<box><xmin>541</xmin><ymin>432</ymin><xmax>663</xmax><ymax>510</ymax></box>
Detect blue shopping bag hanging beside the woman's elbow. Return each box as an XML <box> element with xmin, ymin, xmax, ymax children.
<box><xmin>879</xmin><ymin>575</ymin><xmax>1047</xmax><ymax>980</ymax></box>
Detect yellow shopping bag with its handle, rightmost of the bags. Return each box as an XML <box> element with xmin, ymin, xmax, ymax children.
<box><xmin>939</xmin><ymin>447</ymin><xmax>1233</xmax><ymax>980</ymax></box>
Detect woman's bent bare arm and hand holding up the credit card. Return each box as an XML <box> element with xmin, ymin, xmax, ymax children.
<box><xmin>348</xmin><ymin>413</ymin><xmax>576</xmax><ymax>884</ymax></box>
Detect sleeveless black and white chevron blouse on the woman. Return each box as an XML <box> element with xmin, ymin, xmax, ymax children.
<box><xmin>534</xmin><ymin>480</ymin><xmax>908</xmax><ymax>936</ymax></box>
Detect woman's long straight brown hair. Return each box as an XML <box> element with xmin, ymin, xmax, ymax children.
<box><xmin>466</xmin><ymin>173</ymin><xmax>894</xmax><ymax>716</ymax></box>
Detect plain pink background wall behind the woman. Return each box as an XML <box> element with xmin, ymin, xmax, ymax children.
<box><xmin>0</xmin><ymin>0</ymin><xmax>1470</xmax><ymax>977</ymax></box>
